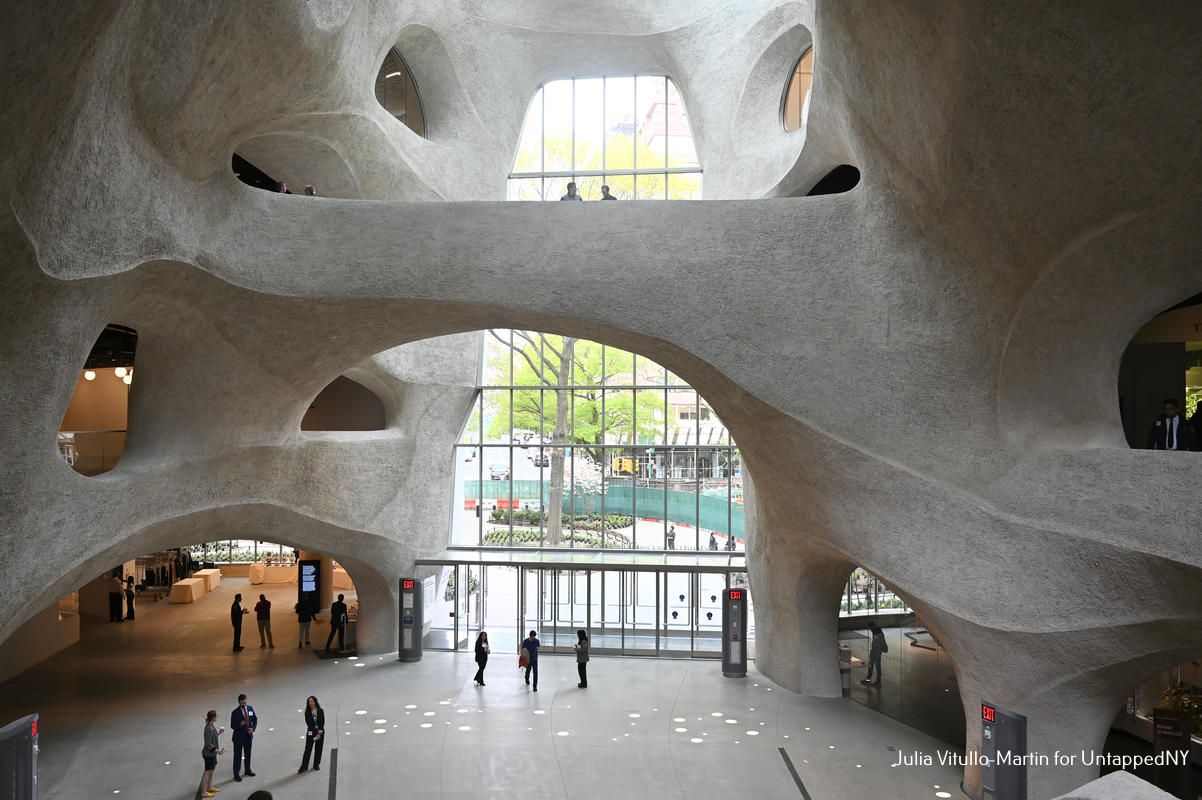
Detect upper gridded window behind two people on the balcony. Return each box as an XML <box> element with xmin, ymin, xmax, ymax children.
<box><xmin>508</xmin><ymin>76</ymin><xmax>701</xmax><ymax>201</ymax></box>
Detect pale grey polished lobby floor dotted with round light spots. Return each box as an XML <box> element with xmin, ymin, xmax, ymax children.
<box><xmin>0</xmin><ymin>580</ymin><xmax>963</xmax><ymax>800</ymax></box>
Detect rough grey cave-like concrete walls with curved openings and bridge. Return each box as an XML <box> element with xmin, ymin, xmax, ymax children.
<box><xmin>0</xmin><ymin>0</ymin><xmax>1202</xmax><ymax>798</ymax></box>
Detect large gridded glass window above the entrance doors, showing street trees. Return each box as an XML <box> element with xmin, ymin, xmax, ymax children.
<box><xmin>452</xmin><ymin>329</ymin><xmax>746</xmax><ymax>551</ymax></box>
